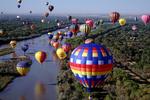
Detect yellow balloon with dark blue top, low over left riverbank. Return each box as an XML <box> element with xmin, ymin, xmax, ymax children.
<box><xmin>16</xmin><ymin>61</ymin><xmax>31</xmax><ymax>76</ymax></box>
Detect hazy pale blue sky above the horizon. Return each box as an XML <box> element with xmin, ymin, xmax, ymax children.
<box><xmin>0</xmin><ymin>0</ymin><xmax>150</xmax><ymax>14</ymax></box>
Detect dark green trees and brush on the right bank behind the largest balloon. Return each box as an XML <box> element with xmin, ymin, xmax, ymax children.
<box><xmin>57</xmin><ymin>23</ymin><xmax>150</xmax><ymax>100</ymax></box>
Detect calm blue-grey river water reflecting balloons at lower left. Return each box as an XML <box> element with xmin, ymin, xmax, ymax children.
<box><xmin>0</xmin><ymin>29</ymin><xmax>67</xmax><ymax>100</ymax></box>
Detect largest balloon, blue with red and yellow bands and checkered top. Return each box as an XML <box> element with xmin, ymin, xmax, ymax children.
<box><xmin>70</xmin><ymin>43</ymin><xmax>113</xmax><ymax>92</ymax></box>
